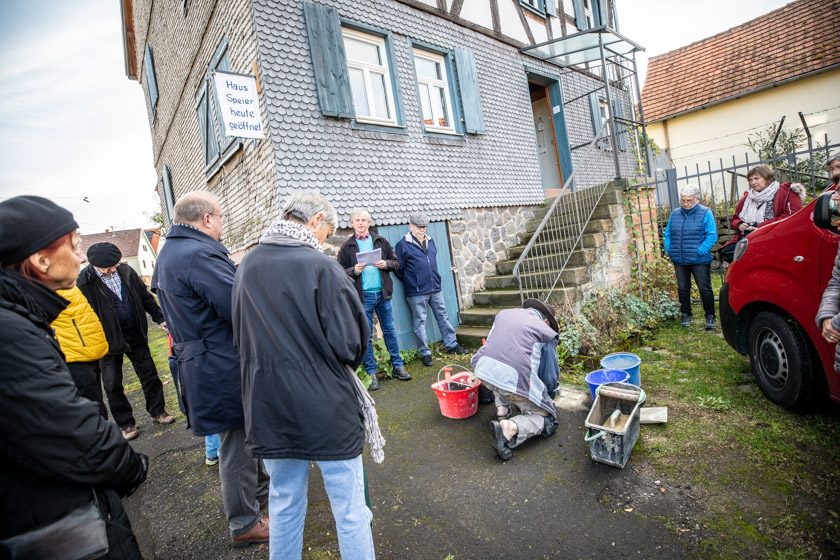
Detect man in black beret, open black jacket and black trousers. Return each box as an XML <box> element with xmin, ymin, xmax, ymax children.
<box><xmin>79</xmin><ymin>238</ymin><xmax>175</xmax><ymax>440</ymax></box>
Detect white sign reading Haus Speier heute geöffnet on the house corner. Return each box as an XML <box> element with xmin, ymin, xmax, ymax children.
<box><xmin>213</xmin><ymin>72</ymin><xmax>265</xmax><ymax>138</ymax></box>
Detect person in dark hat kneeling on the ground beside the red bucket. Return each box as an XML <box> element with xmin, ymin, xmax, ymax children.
<box><xmin>470</xmin><ymin>299</ymin><xmax>560</xmax><ymax>461</ymax></box>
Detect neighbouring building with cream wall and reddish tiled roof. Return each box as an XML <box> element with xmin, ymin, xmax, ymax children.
<box><xmin>642</xmin><ymin>0</ymin><xmax>840</xmax><ymax>178</ymax></box>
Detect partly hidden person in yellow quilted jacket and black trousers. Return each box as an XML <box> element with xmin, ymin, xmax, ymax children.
<box><xmin>52</xmin><ymin>286</ymin><xmax>108</xmax><ymax>418</ymax></box>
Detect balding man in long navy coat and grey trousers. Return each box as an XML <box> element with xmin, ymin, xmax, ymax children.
<box><xmin>152</xmin><ymin>192</ymin><xmax>268</xmax><ymax>546</ymax></box>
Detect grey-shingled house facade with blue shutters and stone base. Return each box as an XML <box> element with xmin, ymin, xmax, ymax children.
<box><xmin>122</xmin><ymin>0</ymin><xmax>632</xmax><ymax>346</ymax></box>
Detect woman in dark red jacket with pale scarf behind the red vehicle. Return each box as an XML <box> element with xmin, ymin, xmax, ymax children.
<box><xmin>719</xmin><ymin>164</ymin><xmax>805</xmax><ymax>262</ymax></box>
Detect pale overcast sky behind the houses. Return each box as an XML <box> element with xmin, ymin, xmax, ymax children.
<box><xmin>0</xmin><ymin>0</ymin><xmax>792</xmax><ymax>233</ymax></box>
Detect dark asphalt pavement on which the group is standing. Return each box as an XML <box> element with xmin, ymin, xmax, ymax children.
<box><xmin>125</xmin><ymin>361</ymin><xmax>693</xmax><ymax>560</ymax></box>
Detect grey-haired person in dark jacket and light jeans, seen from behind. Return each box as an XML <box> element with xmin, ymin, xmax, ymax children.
<box><xmin>230</xmin><ymin>193</ymin><xmax>374</xmax><ymax>560</ymax></box>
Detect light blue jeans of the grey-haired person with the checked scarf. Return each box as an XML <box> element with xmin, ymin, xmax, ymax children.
<box><xmin>264</xmin><ymin>455</ymin><xmax>376</xmax><ymax>560</ymax></box>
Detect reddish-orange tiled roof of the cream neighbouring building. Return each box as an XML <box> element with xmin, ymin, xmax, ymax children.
<box><xmin>642</xmin><ymin>0</ymin><xmax>840</xmax><ymax>122</ymax></box>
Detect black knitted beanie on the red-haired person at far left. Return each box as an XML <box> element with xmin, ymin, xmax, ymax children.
<box><xmin>0</xmin><ymin>195</ymin><xmax>79</xmax><ymax>266</ymax></box>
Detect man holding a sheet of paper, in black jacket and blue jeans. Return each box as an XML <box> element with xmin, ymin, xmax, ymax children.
<box><xmin>338</xmin><ymin>209</ymin><xmax>411</xmax><ymax>391</ymax></box>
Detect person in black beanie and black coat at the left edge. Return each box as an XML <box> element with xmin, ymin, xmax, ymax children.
<box><xmin>0</xmin><ymin>196</ymin><xmax>148</xmax><ymax>558</ymax></box>
